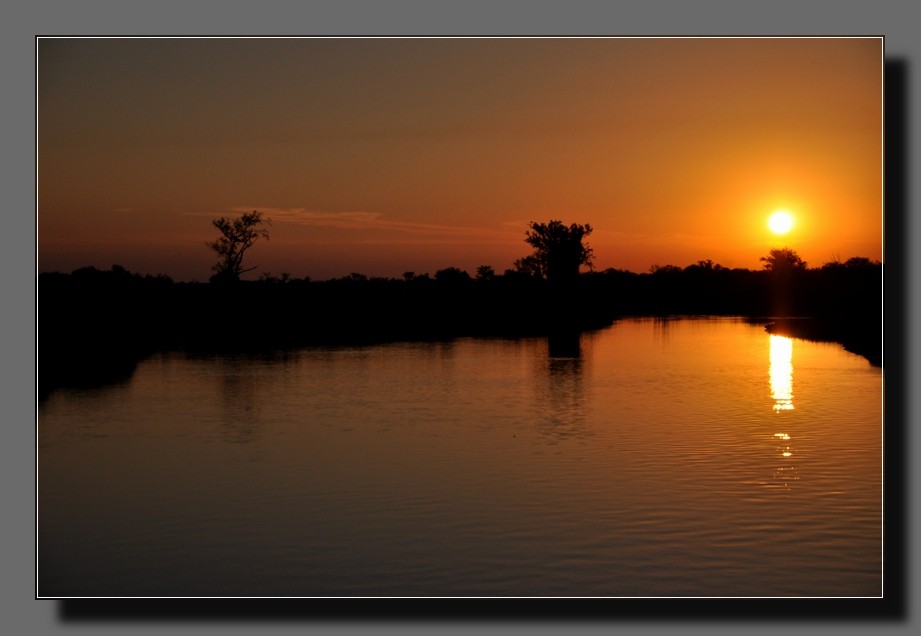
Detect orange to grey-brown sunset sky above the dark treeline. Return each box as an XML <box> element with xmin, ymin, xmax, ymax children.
<box><xmin>36</xmin><ymin>38</ymin><xmax>883</xmax><ymax>281</ymax></box>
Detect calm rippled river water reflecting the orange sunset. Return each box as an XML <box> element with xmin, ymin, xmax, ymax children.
<box><xmin>37</xmin><ymin>319</ymin><xmax>883</xmax><ymax>597</ymax></box>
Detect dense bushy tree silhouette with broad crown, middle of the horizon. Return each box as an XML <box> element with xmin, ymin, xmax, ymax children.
<box><xmin>515</xmin><ymin>221</ymin><xmax>594</xmax><ymax>282</ymax></box>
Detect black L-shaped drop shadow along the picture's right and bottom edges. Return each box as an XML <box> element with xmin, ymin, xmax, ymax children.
<box><xmin>50</xmin><ymin>59</ymin><xmax>912</xmax><ymax>624</ymax></box>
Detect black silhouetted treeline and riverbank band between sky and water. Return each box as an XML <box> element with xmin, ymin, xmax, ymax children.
<box><xmin>38</xmin><ymin>258</ymin><xmax>882</xmax><ymax>394</ymax></box>
